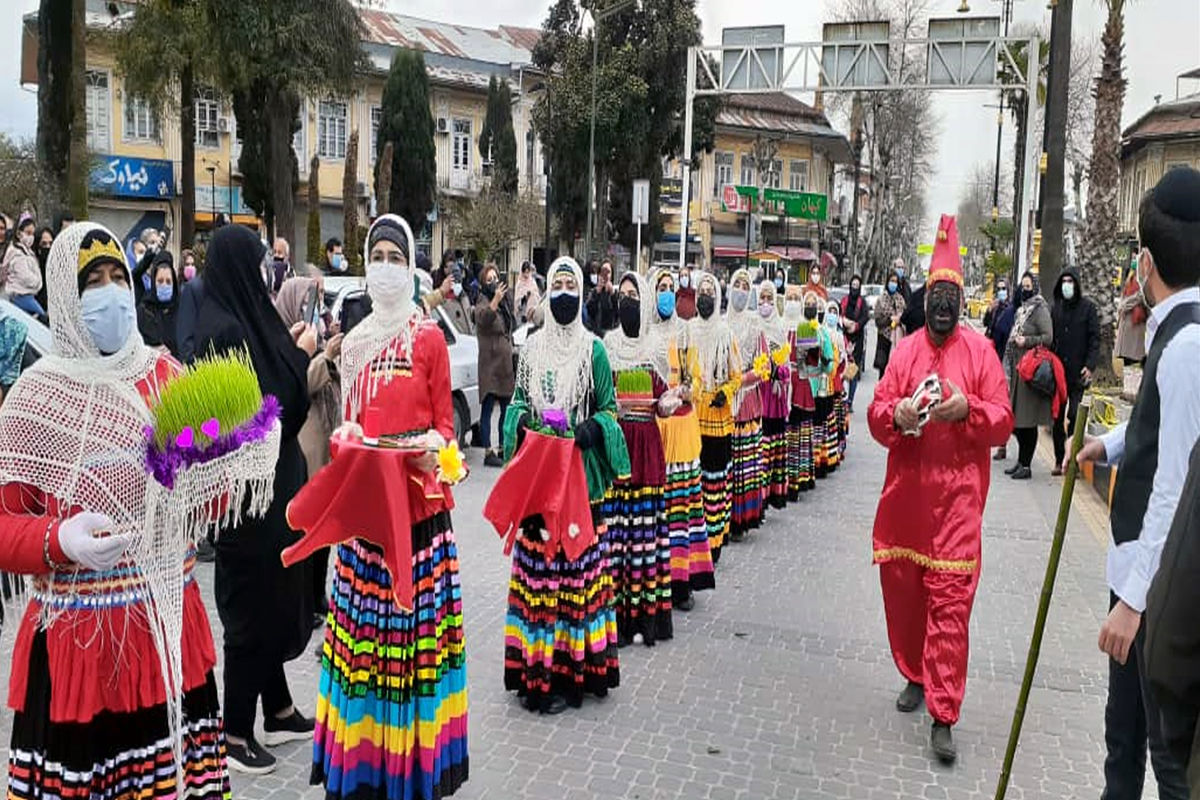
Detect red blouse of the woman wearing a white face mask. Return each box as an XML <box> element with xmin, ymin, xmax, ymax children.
<box><xmin>347</xmin><ymin>320</ymin><xmax>455</xmax><ymax>522</ymax></box>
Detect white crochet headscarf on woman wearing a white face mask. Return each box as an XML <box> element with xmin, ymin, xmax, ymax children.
<box><xmin>341</xmin><ymin>213</ymin><xmax>422</xmax><ymax>422</ymax></box>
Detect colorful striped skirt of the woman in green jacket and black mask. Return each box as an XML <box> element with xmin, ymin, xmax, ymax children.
<box><xmin>504</xmin><ymin>505</ymin><xmax>620</xmax><ymax>711</ymax></box>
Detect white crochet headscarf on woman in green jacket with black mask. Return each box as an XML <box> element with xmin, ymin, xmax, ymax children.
<box><xmin>517</xmin><ymin>257</ymin><xmax>596</xmax><ymax>425</ymax></box>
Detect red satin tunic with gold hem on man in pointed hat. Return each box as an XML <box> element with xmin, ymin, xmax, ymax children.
<box><xmin>866</xmin><ymin>326</ymin><xmax>1013</xmax><ymax>572</ymax></box>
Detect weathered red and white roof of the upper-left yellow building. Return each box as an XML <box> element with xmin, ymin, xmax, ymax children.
<box><xmin>361</xmin><ymin>8</ymin><xmax>540</xmax><ymax>65</ymax></box>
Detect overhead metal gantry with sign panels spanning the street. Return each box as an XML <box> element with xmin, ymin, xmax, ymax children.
<box><xmin>679</xmin><ymin>17</ymin><xmax>1040</xmax><ymax>271</ymax></box>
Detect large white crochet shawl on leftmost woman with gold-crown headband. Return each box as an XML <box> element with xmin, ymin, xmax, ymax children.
<box><xmin>0</xmin><ymin>222</ymin><xmax>280</xmax><ymax>780</ymax></box>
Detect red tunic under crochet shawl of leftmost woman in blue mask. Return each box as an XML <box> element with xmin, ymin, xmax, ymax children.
<box><xmin>0</xmin><ymin>355</ymin><xmax>216</xmax><ymax>722</ymax></box>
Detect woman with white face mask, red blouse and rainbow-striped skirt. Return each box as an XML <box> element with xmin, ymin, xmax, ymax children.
<box><xmin>311</xmin><ymin>215</ymin><xmax>469</xmax><ymax>800</ymax></box>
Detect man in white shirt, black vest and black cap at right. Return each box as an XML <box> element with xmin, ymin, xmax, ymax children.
<box><xmin>1079</xmin><ymin>168</ymin><xmax>1200</xmax><ymax>800</ymax></box>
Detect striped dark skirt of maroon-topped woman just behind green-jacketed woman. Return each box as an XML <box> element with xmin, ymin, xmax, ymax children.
<box><xmin>604</xmin><ymin>480</ymin><xmax>674</xmax><ymax>646</ymax></box>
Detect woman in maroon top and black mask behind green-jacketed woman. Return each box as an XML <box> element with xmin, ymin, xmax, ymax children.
<box><xmin>604</xmin><ymin>271</ymin><xmax>678</xmax><ymax>646</ymax></box>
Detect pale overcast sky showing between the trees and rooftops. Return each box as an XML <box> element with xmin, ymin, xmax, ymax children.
<box><xmin>0</xmin><ymin>0</ymin><xmax>1200</xmax><ymax>236</ymax></box>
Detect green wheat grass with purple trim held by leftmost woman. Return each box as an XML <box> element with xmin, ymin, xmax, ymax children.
<box><xmin>151</xmin><ymin>349</ymin><xmax>263</xmax><ymax>450</ymax></box>
